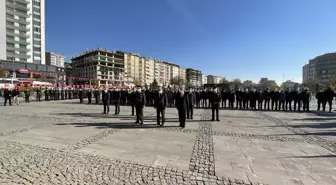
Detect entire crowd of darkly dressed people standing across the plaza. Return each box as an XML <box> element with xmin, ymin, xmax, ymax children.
<box><xmin>3</xmin><ymin>87</ymin><xmax>335</xmax><ymax>127</ymax></box>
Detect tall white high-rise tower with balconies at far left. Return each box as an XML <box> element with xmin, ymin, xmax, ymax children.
<box><xmin>0</xmin><ymin>0</ymin><xmax>45</xmax><ymax>64</ymax></box>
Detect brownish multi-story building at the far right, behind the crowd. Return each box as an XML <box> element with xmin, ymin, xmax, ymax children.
<box><xmin>302</xmin><ymin>53</ymin><xmax>336</xmax><ymax>83</ymax></box>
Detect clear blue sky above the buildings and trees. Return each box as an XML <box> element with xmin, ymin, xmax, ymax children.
<box><xmin>46</xmin><ymin>0</ymin><xmax>336</xmax><ymax>83</ymax></box>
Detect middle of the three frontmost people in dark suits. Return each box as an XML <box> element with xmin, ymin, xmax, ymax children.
<box><xmin>154</xmin><ymin>87</ymin><xmax>168</xmax><ymax>126</ymax></box>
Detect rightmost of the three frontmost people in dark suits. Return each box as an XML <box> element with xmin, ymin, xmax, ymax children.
<box><xmin>176</xmin><ymin>89</ymin><xmax>189</xmax><ymax>128</ymax></box>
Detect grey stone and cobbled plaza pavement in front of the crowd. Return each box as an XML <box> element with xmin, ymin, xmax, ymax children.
<box><xmin>0</xmin><ymin>100</ymin><xmax>336</xmax><ymax>185</ymax></box>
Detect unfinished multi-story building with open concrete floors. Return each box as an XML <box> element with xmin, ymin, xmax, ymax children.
<box><xmin>71</xmin><ymin>48</ymin><xmax>124</xmax><ymax>86</ymax></box>
